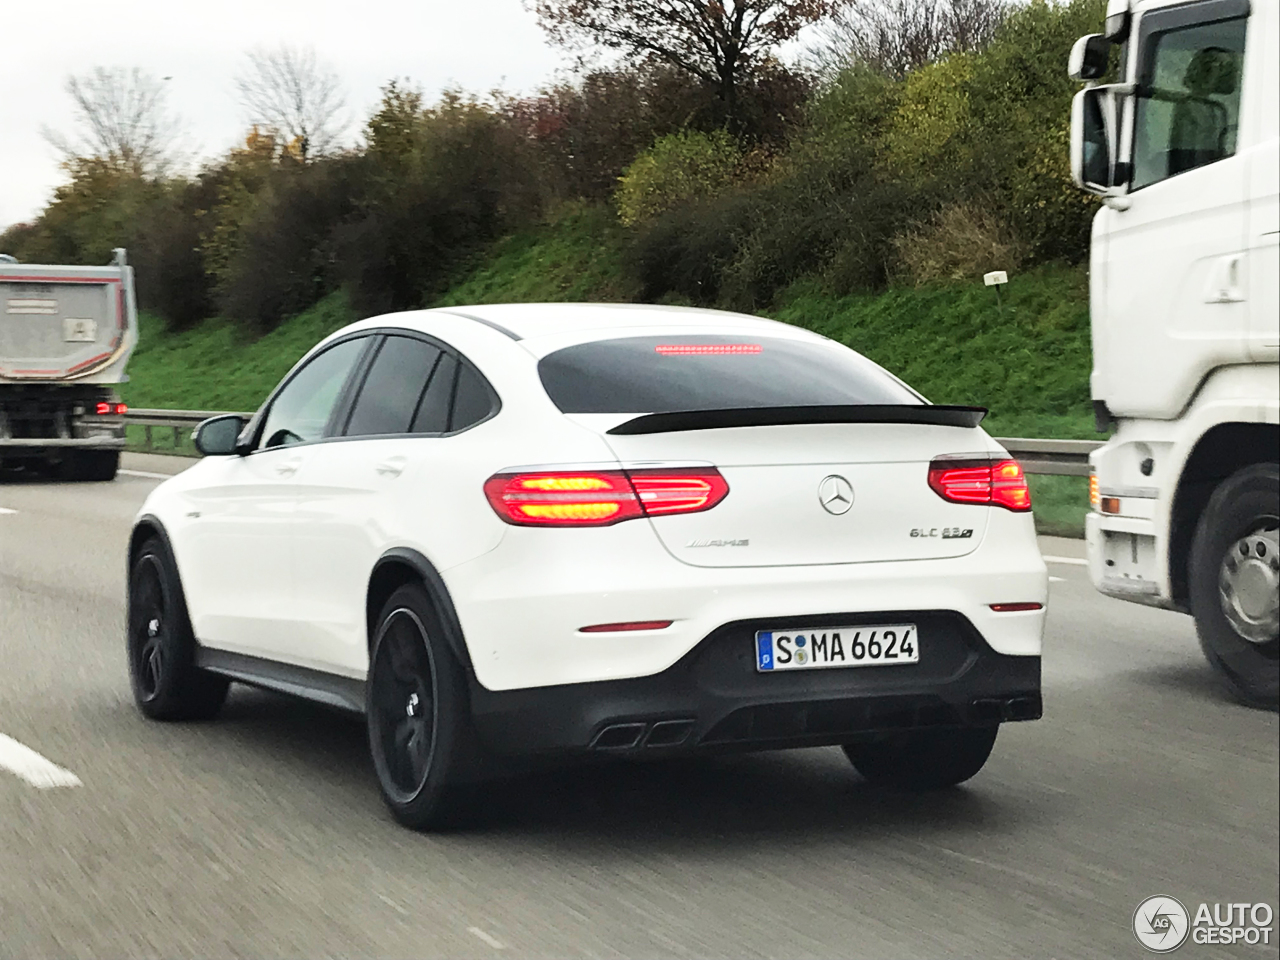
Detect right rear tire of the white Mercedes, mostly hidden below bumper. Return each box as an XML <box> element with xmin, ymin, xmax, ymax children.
<box><xmin>844</xmin><ymin>726</ymin><xmax>998</xmax><ymax>790</ymax></box>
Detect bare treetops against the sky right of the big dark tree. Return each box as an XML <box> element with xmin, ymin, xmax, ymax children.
<box><xmin>812</xmin><ymin>0</ymin><xmax>1007</xmax><ymax>78</ymax></box>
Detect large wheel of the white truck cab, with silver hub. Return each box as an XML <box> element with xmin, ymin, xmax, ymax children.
<box><xmin>1189</xmin><ymin>463</ymin><xmax>1280</xmax><ymax>710</ymax></box>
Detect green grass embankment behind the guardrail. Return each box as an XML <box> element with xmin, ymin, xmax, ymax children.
<box><xmin>124</xmin><ymin>209</ymin><xmax>1096</xmax><ymax>534</ymax></box>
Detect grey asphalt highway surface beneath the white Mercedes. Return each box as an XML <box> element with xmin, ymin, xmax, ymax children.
<box><xmin>0</xmin><ymin>457</ymin><xmax>1280</xmax><ymax>960</ymax></box>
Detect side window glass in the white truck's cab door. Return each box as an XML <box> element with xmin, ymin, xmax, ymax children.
<box><xmin>1133</xmin><ymin>18</ymin><xmax>1248</xmax><ymax>189</ymax></box>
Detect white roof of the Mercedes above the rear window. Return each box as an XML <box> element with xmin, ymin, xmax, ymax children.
<box><xmin>425</xmin><ymin>303</ymin><xmax>814</xmax><ymax>340</ymax></box>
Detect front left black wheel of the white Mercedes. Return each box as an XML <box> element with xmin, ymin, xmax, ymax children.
<box><xmin>125</xmin><ymin>538</ymin><xmax>230</xmax><ymax>721</ymax></box>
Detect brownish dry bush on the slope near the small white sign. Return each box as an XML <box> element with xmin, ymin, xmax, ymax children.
<box><xmin>892</xmin><ymin>202</ymin><xmax>1024</xmax><ymax>287</ymax></box>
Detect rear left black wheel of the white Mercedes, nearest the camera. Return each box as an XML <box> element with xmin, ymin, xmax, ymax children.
<box><xmin>365</xmin><ymin>584</ymin><xmax>479</xmax><ymax>831</ymax></box>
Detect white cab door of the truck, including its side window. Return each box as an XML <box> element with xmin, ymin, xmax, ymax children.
<box><xmin>1093</xmin><ymin>0</ymin><xmax>1249</xmax><ymax>419</ymax></box>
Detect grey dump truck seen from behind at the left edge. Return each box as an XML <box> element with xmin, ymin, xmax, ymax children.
<box><xmin>0</xmin><ymin>250</ymin><xmax>138</xmax><ymax>480</ymax></box>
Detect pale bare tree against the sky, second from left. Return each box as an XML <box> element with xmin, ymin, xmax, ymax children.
<box><xmin>236</xmin><ymin>45</ymin><xmax>347</xmax><ymax>160</ymax></box>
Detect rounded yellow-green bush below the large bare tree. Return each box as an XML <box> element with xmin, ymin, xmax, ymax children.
<box><xmin>617</xmin><ymin>131</ymin><xmax>742</xmax><ymax>225</ymax></box>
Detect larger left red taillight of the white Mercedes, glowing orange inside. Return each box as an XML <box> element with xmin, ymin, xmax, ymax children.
<box><xmin>484</xmin><ymin>467</ymin><xmax>728</xmax><ymax>526</ymax></box>
